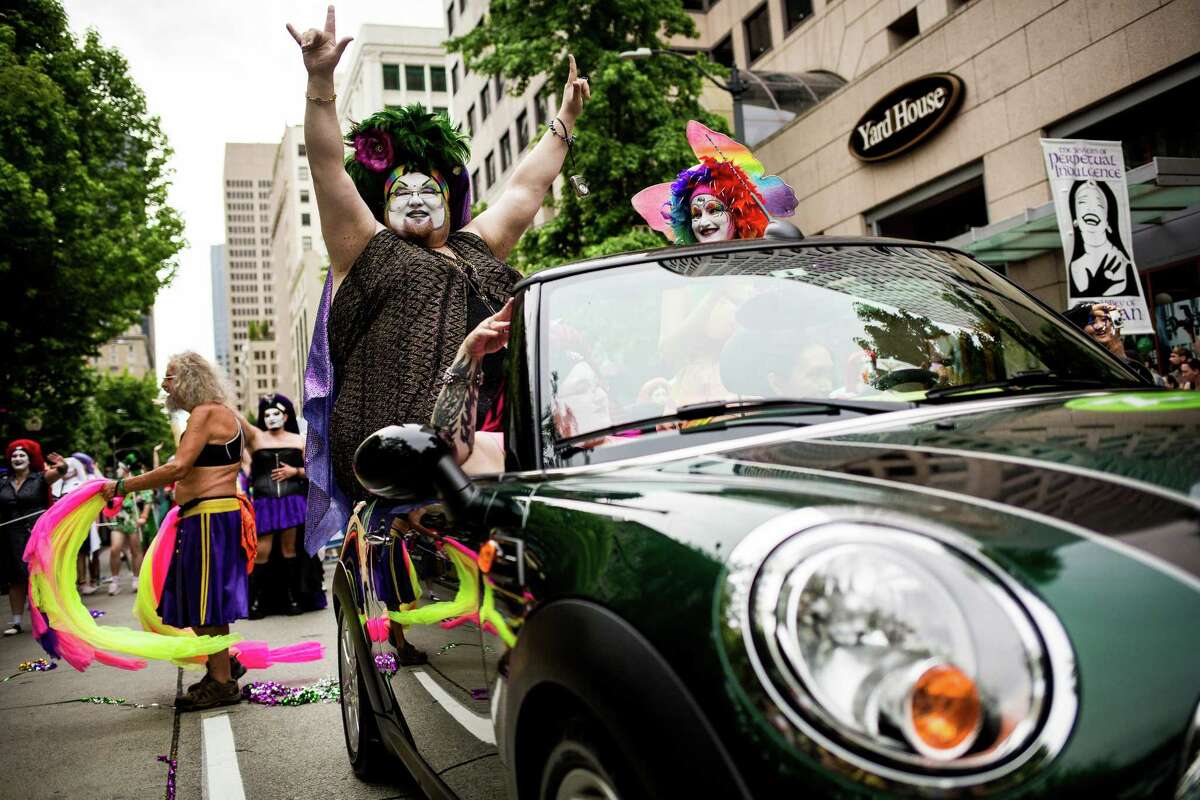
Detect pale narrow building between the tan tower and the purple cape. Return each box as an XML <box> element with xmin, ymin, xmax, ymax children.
<box><xmin>270</xmin><ymin>125</ymin><xmax>329</xmax><ymax>405</ymax></box>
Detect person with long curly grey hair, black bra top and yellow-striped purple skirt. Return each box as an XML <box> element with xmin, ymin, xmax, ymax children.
<box><xmin>103</xmin><ymin>353</ymin><xmax>253</xmax><ymax>711</ymax></box>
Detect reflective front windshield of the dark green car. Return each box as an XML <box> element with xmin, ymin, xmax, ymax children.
<box><xmin>540</xmin><ymin>245</ymin><xmax>1135</xmax><ymax>447</ymax></box>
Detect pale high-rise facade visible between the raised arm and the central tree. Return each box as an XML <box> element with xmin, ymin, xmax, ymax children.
<box><xmin>442</xmin><ymin>0</ymin><xmax>562</xmax><ymax>219</ymax></box>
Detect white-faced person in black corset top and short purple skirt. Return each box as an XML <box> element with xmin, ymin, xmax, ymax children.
<box><xmin>242</xmin><ymin>395</ymin><xmax>308</xmax><ymax>619</ymax></box>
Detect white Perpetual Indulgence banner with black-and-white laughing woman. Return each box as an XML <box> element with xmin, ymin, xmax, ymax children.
<box><xmin>1042</xmin><ymin>139</ymin><xmax>1153</xmax><ymax>333</ymax></box>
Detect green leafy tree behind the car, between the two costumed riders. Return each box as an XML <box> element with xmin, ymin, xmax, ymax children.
<box><xmin>446</xmin><ymin>0</ymin><xmax>727</xmax><ymax>272</ymax></box>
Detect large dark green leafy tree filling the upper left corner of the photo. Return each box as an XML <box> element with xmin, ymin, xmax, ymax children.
<box><xmin>0</xmin><ymin>0</ymin><xmax>184</xmax><ymax>439</ymax></box>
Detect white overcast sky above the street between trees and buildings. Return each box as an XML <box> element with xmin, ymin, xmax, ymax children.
<box><xmin>62</xmin><ymin>0</ymin><xmax>442</xmax><ymax>374</ymax></box>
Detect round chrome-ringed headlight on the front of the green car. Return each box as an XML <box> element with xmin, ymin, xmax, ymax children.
<box><xmin>721</xmin><ymin>507</ymin><xmax>1079</xmax><ymax>795</ymax></box>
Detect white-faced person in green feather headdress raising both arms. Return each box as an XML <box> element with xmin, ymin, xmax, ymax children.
<box><xmin>288</xmin><ymin>6</ymin><xmax>590</xmax><ymax>553</ymax></box>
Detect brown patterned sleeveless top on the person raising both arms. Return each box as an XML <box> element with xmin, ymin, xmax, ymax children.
<box><xmin>329</xmin><ymin>229</ymin><xmax>521</xmax><ymax>499</ymax></box>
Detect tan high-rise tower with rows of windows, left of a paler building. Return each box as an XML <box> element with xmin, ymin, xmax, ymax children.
<box><xmin>224</xmin><ymin>143</ymin><xmax>281</xmax><ymax>413</ymax></box>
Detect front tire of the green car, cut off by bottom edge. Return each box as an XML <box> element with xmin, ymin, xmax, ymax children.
<box><xmin>538</xmin><ymin>717</ymin><xmax>646</xmax><ymax>800</ymax></box>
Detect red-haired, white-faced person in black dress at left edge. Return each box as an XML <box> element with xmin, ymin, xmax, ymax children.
<box><xmin>0</xmin><ymin>439</ymin><xmax>67</xmax><ymax>636</ymax></box>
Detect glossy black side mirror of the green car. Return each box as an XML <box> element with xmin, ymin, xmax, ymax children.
<box><xmin>354</xmin><ymin>425</ymin><xmax>487</xmax><ymax>518</ymax></box>
